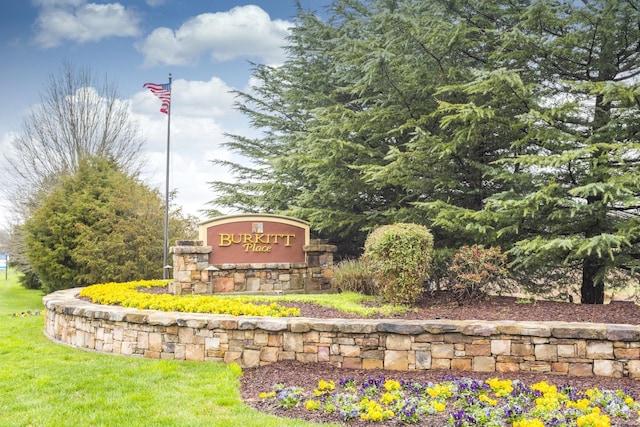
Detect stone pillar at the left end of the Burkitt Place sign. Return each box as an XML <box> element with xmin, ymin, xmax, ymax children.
<box><xmin>169</xmin><ymin>240</ymin><xmax>211</xmax><ymax>295</ymax></box>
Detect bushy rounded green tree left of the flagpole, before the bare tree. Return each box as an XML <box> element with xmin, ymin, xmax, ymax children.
<box><xmin>22</xmin><ymin>158</ymin><xmax>195</xmax><ymax>291</ymax></box>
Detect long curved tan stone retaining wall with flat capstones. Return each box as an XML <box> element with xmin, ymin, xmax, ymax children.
<box><xmin>44</xmin><ymin>289</ymin><xmax>640</xmax><ymax>378</ymax></box>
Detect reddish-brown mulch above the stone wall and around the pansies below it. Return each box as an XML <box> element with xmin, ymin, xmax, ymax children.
<box><xmin>240</xmin><ymin>294</ymin><xmax>640</xmax><ymax>426</ymax></box>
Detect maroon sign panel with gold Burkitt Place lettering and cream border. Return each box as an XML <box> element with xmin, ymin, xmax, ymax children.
<box><xmin>200</xmin><ymin>214</ymin><xmax>309</xmax><ymax>264</ymax></box>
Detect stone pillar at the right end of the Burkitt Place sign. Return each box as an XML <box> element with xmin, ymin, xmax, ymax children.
<box><xmin>302</xmin><ymin>239</ymin><xmax>338</xmax><ymax>293</ymax></box>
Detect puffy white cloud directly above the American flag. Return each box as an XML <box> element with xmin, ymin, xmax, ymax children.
<box><xmin>137</xmin><ymin>5</ymin><xmax>293</xmax><ymax>66</ymax></box>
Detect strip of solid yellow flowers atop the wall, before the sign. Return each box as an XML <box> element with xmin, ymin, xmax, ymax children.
<box><xmin>80</xmin><ymin>280</ymin><xmax>300</xmax><ymax>317</ymax></box>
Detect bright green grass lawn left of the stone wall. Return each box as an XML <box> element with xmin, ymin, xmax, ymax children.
<box><xmin>0</xmin><ymin>272</ymin><xmax>336</xmax><ymax>427</ymax></box>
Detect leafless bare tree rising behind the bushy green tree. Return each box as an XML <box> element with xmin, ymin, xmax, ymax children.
<box><xmin>4</xmin><ymin>62</ymin><xmax>144</xmax><ymax>219</ymax></box>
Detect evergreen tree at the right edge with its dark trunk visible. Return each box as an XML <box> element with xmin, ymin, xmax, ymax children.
<box><xmin>425</xmin><ymin>1</ymin><xmax>640</xmax><ymax>304</ymax></box>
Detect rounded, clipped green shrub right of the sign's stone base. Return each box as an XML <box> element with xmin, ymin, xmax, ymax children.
<box><xmin>363</xmin><ymin>223</ymin><xmax>433</xmax><ymax>304</ymax></box>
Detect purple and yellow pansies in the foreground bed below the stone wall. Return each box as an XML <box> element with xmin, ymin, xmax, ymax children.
<box><xmin>259</xmin><ymin>376</ymin><xmax>640</xmax><ymax>427</ymax></box>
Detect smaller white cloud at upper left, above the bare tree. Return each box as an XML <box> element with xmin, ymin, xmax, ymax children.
<box><xmin>35</xmin><ymin>0</ymin><xmax>140</xmax><ymax>48</ymax></box>
